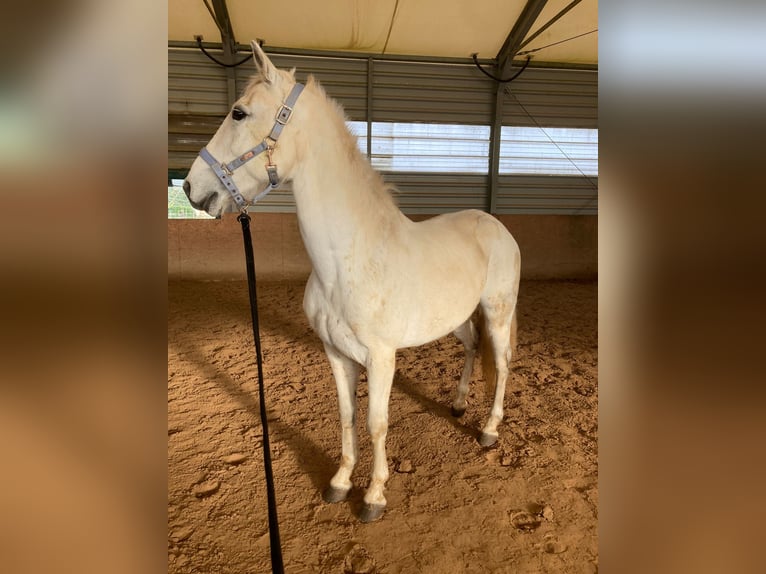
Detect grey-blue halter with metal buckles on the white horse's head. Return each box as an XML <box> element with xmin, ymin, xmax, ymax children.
<box><xmin>199</xmin><ymin>84</ymin><xmax>303</xmax><ymax>211</ymax></box>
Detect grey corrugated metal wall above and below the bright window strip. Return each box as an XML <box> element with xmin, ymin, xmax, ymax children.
<box><xmin>168</xmin><ymin>48</ymin><xmax>598</xmax><ymax>214</ymax></box>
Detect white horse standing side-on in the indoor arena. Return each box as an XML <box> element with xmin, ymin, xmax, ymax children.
<box><xmin>184</xmin><ymin>43</ymin><xmax>521</xmax><ymax>522</ymax></box>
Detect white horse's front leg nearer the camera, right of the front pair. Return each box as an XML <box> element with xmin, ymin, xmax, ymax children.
<box><xmin>359</xmin><ymin>350</ymin><xmax>396</xmax><ymax>522</ymax></box>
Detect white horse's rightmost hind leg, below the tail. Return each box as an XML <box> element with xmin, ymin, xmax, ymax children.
<box><xmin>479</xmin><ymin>298</ymin><xmax>515</xmax><ymax>447</ymax></box>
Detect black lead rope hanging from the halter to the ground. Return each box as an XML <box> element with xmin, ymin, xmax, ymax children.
<box><xmin>237</xmin><ymin>211</ymin><xmax>284</xmax><ymax>574</ymax></box>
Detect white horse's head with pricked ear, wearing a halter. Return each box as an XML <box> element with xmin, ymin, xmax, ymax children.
<box><xmin>183</xmin><ymin>42</ymin><xmax>300</xmax><ymax>217</ymax></box>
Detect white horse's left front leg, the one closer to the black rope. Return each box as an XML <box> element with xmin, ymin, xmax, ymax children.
<box><xmin>322</xmin><ymin>344</ymin><xmax>359</xmax><ymax>502</ymax></box>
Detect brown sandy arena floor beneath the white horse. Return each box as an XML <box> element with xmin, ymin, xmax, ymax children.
<box><xmin>168</xmin><ymin>281</ymin><xmax>598</xmax><ymax>574</ymax></box>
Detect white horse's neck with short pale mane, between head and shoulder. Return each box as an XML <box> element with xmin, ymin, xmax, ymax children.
<box><xmin>293</xmin><ymin>98</ymin><xmax>406</xmax><ymax>281</ymax></box>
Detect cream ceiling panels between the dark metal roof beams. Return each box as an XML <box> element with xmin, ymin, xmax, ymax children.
<box><xmin>168</xmin><ymin>0</ymin><xmax>598</xmax><ymax>64</ymax></box>
